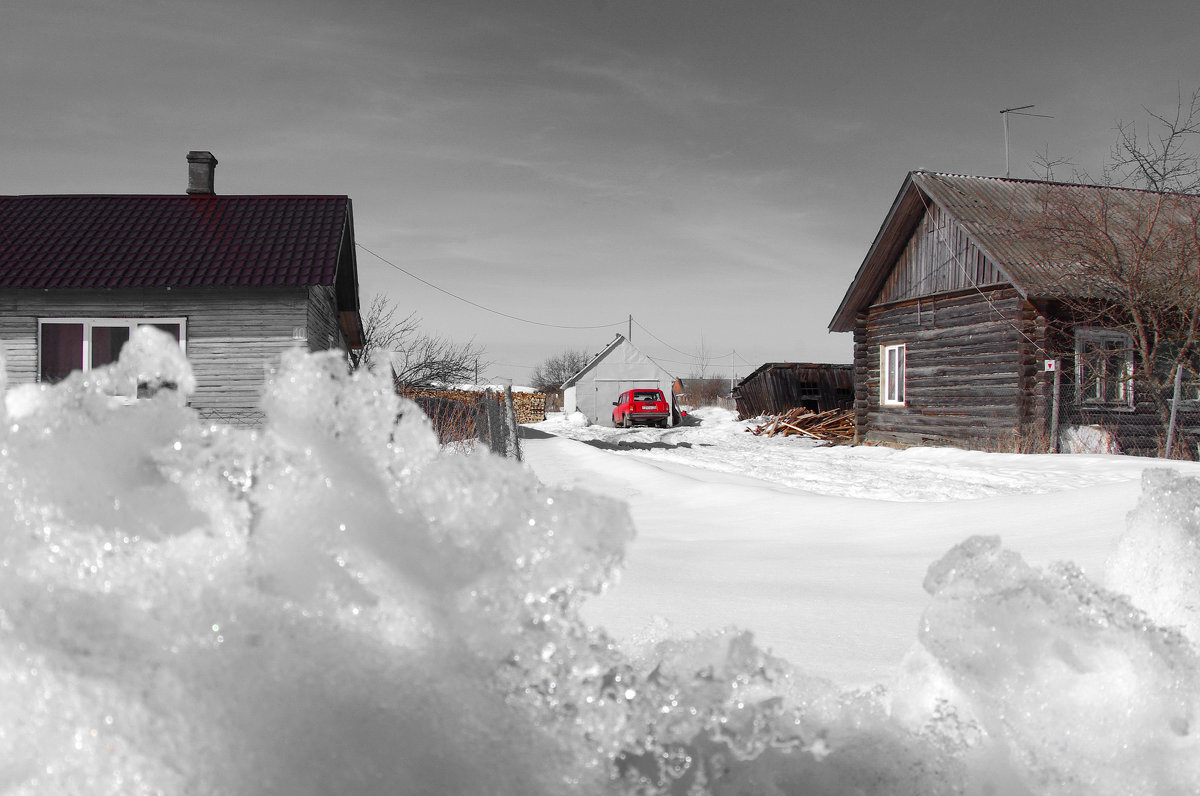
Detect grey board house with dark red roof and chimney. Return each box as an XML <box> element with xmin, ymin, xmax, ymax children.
<box><xmin>0</xmin><ymin>151</ymin><xmax>362</xmax><ymax>425</ymax></box>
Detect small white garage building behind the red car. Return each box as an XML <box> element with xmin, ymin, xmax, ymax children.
<box><xmin>563</xmin><ymin>334</ymin><xmax>679</xmax><ymax>426</ymax></box>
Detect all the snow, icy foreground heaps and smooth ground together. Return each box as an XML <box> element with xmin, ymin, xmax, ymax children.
<box><xmin>9</xmin><ymin>340</ymin><xmax>1200</xmax><ymax>796</ymax></box>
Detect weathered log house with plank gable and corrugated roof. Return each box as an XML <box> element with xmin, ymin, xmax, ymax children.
<box><xmin>829</xmin><ymin>170</ymin><xmax>1200</xmax><ymax>454</ymax></box>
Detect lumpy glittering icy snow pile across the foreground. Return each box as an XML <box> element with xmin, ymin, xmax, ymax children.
<box><xmin>0</xmin><ymin>330</ymin><xmax>1200</xmax><ymax>795</ymax></box>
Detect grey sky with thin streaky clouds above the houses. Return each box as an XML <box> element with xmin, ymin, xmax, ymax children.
<box><xmin>7</xmin><ymin>0</ymin><xmax>1200</xmax><ymax>383</ymax></box>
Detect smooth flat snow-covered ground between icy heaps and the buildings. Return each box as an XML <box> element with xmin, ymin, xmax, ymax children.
<box><xmin>523</xmin><ymin>408</ymin><xmax>1200</xmax><ymax>684</ymax></box>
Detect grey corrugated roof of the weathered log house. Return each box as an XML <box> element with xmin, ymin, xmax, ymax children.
<box><xmin>829</xmin><ymin>170</ymin><xmax>1200</xmax><ymax>331</ymax></box>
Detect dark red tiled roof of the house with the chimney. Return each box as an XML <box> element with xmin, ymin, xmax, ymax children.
<box><xmin>0</xmin><ymin>194</ymin><xmax>350</xmax><ymax>289</ymax></box>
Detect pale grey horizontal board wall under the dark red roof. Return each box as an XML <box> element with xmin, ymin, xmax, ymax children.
<box><xmin>0</xmin><ymin>288</ymin><xmax>316</xmax><ymax>424</ymax></box>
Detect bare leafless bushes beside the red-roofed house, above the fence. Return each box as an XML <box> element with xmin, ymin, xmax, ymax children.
<box><xmin>350</xmin><ymin>294</ymin><xmax>487</xmax><ymax>385</ymax></box>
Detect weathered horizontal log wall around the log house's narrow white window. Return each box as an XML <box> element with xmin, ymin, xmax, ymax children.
<box><xmin>854</xmin><ymin>286</ymin><xmax>1044</xmax><ymax>444</ymax></box>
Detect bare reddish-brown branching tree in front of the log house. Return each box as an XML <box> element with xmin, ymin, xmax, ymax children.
<box><xmin>1021</xmin><ymin>91</ymin><xmax>1200</xmax><ymax>449</ymax></box>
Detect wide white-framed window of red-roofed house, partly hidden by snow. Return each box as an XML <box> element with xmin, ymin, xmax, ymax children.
<box><xmin>37</xmin><ymin>318</ymin><xmax>187</xmax><ymax>397</ymax></box>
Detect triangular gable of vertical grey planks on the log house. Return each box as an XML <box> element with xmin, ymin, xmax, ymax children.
<box><xmin>875</xmin><ymin>204</ymin><xmax>1006</xmax><ymax>304</ymax></box>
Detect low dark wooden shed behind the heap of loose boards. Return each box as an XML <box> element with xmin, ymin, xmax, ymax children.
<box><xmin>733</xmin><ymin>363</ymin><xmax>854</xmax><ymax>419</ymax></box>
